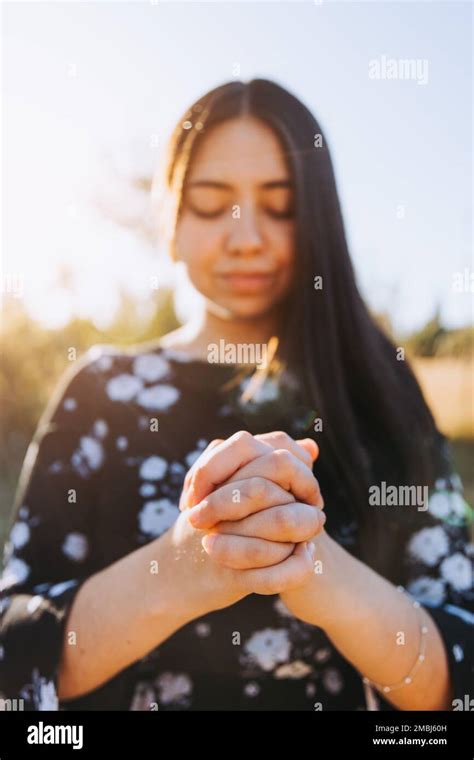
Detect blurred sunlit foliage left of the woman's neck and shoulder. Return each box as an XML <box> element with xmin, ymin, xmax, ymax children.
<box><xmin>0</xmin><ymin>290</ymin><xmax>179</xmax><ymax>480</ymax></box>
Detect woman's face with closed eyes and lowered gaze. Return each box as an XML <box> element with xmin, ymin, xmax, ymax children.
<box><xmin>174</xmin><ymin>116</ymin><xmax>294</xmax><ymax>318</ymax></box>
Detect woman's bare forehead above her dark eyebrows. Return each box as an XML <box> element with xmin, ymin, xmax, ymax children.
<box><xmin>187</xmin><ymin>116</ymin><xmax>289</xmax><ymax>183</ymax></box>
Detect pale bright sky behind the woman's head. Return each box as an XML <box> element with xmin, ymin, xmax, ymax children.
<box><xmin>2</xmin><ymin>0</ymin><xmax>473</xmax><ymax>330</ymax></box>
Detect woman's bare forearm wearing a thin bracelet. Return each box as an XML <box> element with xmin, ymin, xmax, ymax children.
<box><xmin>282</xmin><ymin>533</ymin><xmax>451</xmax><ymax>710</ymax></box>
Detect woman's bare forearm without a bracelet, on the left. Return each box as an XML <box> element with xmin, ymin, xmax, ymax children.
<box><xmin>58</xmin><ymin>534</ymin><xmax>192</xmax><ymax>699</ymax></box>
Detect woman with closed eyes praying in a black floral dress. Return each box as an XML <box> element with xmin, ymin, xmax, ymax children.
<box><xmin>0</xmin><ymin>79</ymin><xmax>472</xmax><ymax>710</ymax></box>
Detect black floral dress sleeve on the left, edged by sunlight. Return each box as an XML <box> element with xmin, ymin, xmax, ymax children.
<box><xmin>0</xmin><ymin>346</ymin><xmax>111</xmax><ymax>710</ymax></box>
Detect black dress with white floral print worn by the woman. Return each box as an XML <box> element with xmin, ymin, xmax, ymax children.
<box><xmin>0</xmin><ymin>344</ymin><xmax>473</xmax><ymax>710</ymax></box>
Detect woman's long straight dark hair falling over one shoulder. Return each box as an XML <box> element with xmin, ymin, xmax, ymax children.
<box><xmin>156</xmin><ymin>79</ymin><xmax>440</xmax><ymax>569</ymax></box>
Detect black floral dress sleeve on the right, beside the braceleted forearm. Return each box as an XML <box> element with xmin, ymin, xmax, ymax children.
<box><xmin>401</xmin><ymin>439</ymin><xmax>474</xmax><ymax>710</ymax></box>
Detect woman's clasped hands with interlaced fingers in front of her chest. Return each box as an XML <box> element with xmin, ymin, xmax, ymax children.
<box><xmin>179</xmin><ymin>431</ymin><xmax>325</xmax><ymax>593</ymax></box>
